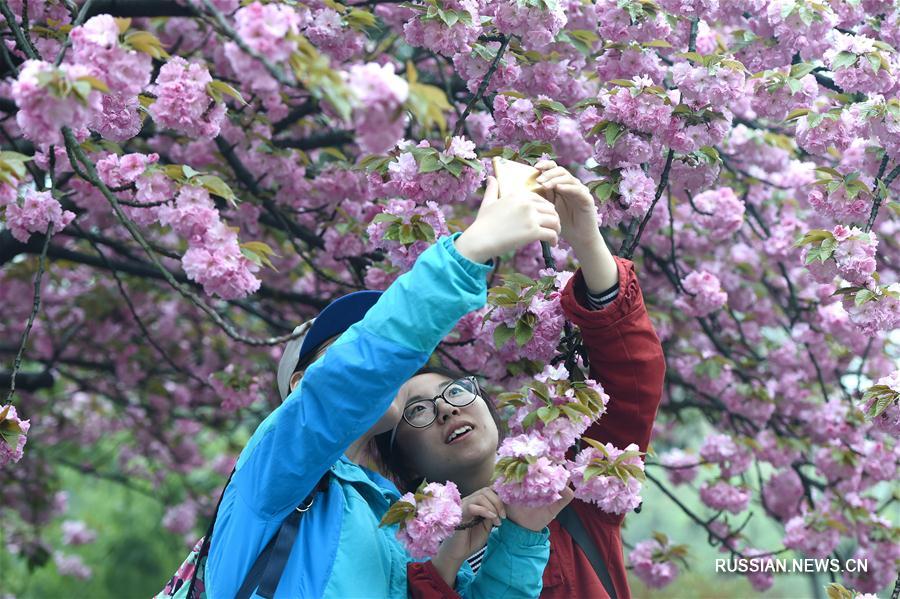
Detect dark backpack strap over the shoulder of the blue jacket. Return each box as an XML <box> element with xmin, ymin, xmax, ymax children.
<box><xmin>235</xmin><ymin>471</ymin><xmax>330</xmax><ymax>599</ymax></box>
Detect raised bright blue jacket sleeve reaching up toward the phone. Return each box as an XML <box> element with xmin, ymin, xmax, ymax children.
<box><xmin>232</xmin><ymin>233</ymin><xmax>491</xmax><ymax>519</ymax></box>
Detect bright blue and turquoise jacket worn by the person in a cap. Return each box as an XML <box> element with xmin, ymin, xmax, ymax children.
<box><xmin>205</xmin><ymin>234</ymin><xmax>550</xmax><ymax>599</ymax></box>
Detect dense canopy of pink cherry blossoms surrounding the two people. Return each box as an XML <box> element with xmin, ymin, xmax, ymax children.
<box><xmin>0</xmin><ymin>0</ymin><xmax>900</xmax><ymax>592</ymax></box>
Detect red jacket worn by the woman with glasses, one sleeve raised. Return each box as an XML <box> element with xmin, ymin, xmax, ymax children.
<box><xmin>407</xmin><ymin>257</ymin><xmax>666</xmax><ymax>599</ymax></box>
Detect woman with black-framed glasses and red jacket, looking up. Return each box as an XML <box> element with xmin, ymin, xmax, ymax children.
<box><xmin>376</xmin><ymin>161</ymin><xmax>665</xmax><ymax>599</ymax></box>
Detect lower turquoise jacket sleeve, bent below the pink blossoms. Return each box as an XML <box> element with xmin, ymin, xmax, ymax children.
<box><xmin>456</xmin><ymin>519</ymin><xmax>550</xmax><ymax>599</ymax></box>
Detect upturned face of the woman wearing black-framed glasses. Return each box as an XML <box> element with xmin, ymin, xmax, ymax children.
<box><xmin>393</xmin><ymin>373</ymin><xmax>499</xmax><ymax>484</ymax></box>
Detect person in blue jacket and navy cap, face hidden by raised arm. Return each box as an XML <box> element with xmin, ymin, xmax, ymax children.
<box><xmin>193</xmin><ymin>177</ymin><xmax>564</xmax><ymax>599</ymax></box>
